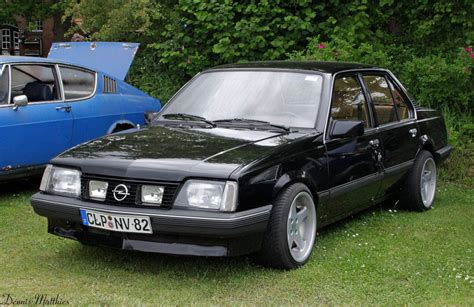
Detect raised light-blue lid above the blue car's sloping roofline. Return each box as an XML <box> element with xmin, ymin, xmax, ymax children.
<box><xmin>48</xmin><ymin>42</ymin><xmax>140</xmax><ymax>80</ymax></box>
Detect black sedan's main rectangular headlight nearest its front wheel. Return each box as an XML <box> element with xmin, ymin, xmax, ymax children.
<box><xmin>174</xmin><ymin>180</ymin><xmax>237</xmax><ymax>212</ymax></box>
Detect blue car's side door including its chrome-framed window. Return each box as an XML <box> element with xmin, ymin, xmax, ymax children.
<box><xmin>0</xmin><ymin>63</ymin><xmax>72</xmax><ymax>173</ymax></box>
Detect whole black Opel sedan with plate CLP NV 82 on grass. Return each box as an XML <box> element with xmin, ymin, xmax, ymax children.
<box><xmin>32</xmin><ymin>62</ymin><xmax>451</xmax><ymax>269</ymax></box>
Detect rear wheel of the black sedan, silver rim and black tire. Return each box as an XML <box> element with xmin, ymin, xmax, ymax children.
<box><xmin>400</xmin><ymin>150</ymin><xmax>437</xmax><ymax>212</ymax></box>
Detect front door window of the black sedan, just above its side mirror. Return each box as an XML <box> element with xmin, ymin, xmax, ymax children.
<box><xmin>331</xmin><ymin>76</ymin><xmax>370</xmax><ymax>128</ymax></box>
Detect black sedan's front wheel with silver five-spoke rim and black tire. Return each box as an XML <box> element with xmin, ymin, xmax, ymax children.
<box><xmin>255</xmin><ymin>183</ymin><xmax>317</xmax><ymax>269</ymax></box>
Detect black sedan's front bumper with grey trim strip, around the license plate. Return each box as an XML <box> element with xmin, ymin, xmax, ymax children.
<box><xmin>31</xmin><ymin>193</ymin><xmax>272</xmax><ymax>256</ymax></box>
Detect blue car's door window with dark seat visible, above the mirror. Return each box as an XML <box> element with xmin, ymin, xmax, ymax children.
<box><xmin>11</xmin><ymin>64</ymin><xmax>61</xmax><ymax>103</ymax></box>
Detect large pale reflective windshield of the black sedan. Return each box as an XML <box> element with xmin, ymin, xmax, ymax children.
<box><xmin>160</xmin><ymin>71</ymin><xmax>323</xmax><ymax>128</ymax></box>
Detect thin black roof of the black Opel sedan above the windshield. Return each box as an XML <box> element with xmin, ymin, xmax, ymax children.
<box><xmin>211</xmin><ymin>61</ymin><xmax>380</xmax><ymax>74</ymax></box>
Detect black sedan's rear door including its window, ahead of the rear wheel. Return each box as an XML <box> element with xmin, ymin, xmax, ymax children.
<box><xmin>363</xmin><ymin>72</ymin><xmax>420</xmax><ymax>197</ymax></box>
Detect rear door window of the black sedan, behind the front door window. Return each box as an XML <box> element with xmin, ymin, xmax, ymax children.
<box><xmin>364</xmin><ymin>75</ymin><xmax>398</xmax><ymax>125</ymax></box>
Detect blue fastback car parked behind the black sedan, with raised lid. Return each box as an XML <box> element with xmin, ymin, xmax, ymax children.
<box><xmin>0</xmin><ymin>42</ymin><xmax>161</xmax><ymax>182</ymax></box>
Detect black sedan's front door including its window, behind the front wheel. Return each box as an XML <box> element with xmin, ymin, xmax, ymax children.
<box><xmin>323</xmin><ymin>73</ymin><xmax>383</xmax><ymax>220</ymax></box>
